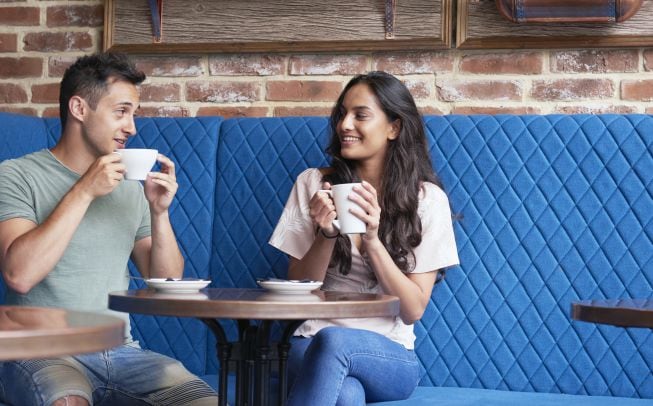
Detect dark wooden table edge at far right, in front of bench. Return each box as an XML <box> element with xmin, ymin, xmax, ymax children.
<box><xmin>571</xmin><ymin>299</ymin><xmax>653</xmax><ymax>328</ymax></box>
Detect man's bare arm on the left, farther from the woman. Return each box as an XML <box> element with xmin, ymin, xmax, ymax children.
<box><xmin>0</xmin><ymin>154</ymin><xmax>124</xmax><ymax>293</ymax></box>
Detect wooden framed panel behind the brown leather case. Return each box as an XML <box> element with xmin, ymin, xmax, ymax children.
<box><xmin>456</xmin><ymin>0</ymin><xmax>653</xmax><ymax>49</ymax></box>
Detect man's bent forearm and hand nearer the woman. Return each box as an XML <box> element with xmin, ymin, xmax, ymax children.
<box><xmin>132</xmin><ymin>154</ymin><xmax>184</xmax><ymax>278</ymax></box>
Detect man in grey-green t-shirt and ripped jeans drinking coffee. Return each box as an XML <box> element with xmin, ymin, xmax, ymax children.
<box><xmin>0</xmin><ymin>53</ymin><xmax>217</xmax><ymax>405</ymax></box>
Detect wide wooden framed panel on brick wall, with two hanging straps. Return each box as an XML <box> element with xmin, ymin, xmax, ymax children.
<box><xmin>104</xmin><ymin>0</ymin><xmax>454</xmax><ymax>53</ymax></box>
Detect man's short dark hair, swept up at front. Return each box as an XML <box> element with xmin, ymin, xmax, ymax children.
<box><xmin>59</xmin><ymin>52</ymin><xmax>145</xmax><ymax>128</ymax></box>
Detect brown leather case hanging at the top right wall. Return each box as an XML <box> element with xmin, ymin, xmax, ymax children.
<box><xmin>495</xmin><ymin>0</ymin><xmax>644</xmax><ymax>23</ymax></box>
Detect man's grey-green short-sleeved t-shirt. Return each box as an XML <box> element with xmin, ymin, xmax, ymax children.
<box><xmin>0</xmin><ymin>149</ymin><xmax>151</xmax><ymax>341</ymax></box>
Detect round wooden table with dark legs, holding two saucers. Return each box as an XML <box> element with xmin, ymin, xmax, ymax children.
<box><xmin>109</xmin><ymin>288</ymin><xmax>399</xmax><ymax>405</ymax></box>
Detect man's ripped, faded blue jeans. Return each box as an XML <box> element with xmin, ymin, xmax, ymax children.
<box><xmin>0</xmin><ymin>343</ymin><xmax>218</xmax><ymax>406</ymax></box>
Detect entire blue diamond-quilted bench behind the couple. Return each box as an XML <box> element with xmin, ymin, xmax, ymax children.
<box><xmin>0</xmin><ymin>114</ymin><xmax>653</xmax><ymax>406</ymax></box>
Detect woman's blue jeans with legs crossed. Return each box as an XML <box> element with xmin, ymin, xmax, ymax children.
<box><xmin>287</xmin><ymin>327</ymin><xmax>419</xmax><ymax>406</ymax></box>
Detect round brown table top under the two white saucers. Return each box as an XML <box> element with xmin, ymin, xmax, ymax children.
<box><xmin>109</xmin><ymin>288</ymin><xmax>399</xmax><ymax>320</ymax></box>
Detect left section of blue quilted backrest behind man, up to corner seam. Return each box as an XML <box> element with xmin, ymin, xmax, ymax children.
<box><xmin>0</xmin><ymin>113</ymin><xmax>222</xmax><ymax>375</ymax></box>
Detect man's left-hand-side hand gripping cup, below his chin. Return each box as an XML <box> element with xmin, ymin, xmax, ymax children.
<box><xmin>77</xmin><ymin>153</ymin><xmax>126</xmax><ymax>200</ymax></box>
